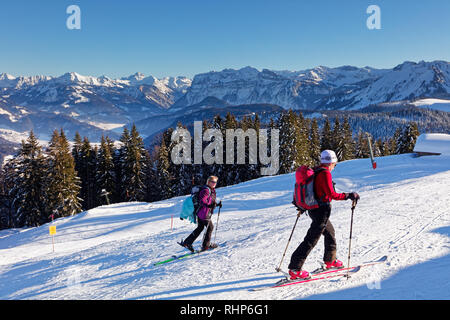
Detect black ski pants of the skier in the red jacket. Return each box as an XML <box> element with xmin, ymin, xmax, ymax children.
<box><xmin>289</xmin><ymin>204</ymin><xmax>336</xmax><ymax>270</ymax></box>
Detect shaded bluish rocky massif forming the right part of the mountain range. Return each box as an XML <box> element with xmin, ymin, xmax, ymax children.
<box><xmin>177</xmin><ymin>61</ymin><xmax>450</xmax><ymax>110</ymax></box>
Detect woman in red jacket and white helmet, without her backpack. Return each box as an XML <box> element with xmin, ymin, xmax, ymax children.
<box><xmin>289</xmin><ymin>150</ymin><xmax>359</xmax><ymax>280</ymax></box>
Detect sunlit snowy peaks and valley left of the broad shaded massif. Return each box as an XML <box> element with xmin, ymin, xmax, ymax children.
<box><xmin>0</xmin><ymin>72</ymin><xmax>191</xmax><ymax>140</ymax></box>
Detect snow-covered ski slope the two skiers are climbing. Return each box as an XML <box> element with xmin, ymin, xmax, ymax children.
<box><xmin>0</xmin><ymin>154</ymin><xmax>450</xmax><ymax>299</ymax></box>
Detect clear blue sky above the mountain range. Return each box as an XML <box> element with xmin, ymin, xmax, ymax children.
<box><xmin>0</xmin><ymin>0</ymin><xmax>450</xmax><ymax>78</ymax></box>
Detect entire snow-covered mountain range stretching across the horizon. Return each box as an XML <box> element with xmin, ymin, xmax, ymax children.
<box><xmin>0</xmin><ymin>61</ymin><xmax>450</xmax><ymax>145</ymax></box>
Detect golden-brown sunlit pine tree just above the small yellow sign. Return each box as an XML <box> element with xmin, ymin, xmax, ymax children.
<box><xmin>46</xmin><ymin>129</ymin><xmax>81</xmax><ymax>217</ymax></box>
